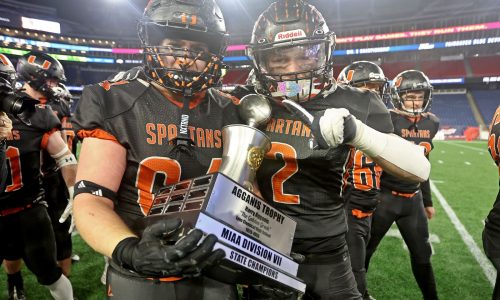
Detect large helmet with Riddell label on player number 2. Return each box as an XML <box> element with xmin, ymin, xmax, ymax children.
<box><xmin>247</xmin><ymin>0</ymin><xmax>335</xmax><ymax>101</ymax></box>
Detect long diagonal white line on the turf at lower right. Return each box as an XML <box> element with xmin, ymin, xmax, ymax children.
<box><xmin>430</xmin><ymin>180</ymin><xmax>496</xmax><ymax>287</ymax></box>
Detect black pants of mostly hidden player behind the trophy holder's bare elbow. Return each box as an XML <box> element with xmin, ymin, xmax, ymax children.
<box><xmin>43</xmin><ymin>172</ymin><xmax>73</xmax><ymax>260</ymax></box>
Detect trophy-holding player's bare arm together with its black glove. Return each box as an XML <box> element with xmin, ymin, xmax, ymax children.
<box><xmin>74</xmin><ymin>138</ymin><xmax>224</xmax><ymax>277</ymax></box>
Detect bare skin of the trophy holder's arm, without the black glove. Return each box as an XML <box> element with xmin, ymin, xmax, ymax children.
<box><xmin>73</xmin><ymin>138</ymin><xmax>135</xmax><ymax>257</ymax></box>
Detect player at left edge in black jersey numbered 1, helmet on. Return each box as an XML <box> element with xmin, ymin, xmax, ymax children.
<box><xmin>0</xmin><ymin>51</ymin><xmax>76</xmax><ymax>299</ymax></box>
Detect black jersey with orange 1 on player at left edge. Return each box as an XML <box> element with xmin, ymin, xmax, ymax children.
<box><xmin>0</xmin><ymin>104</ymin><xmax>61</xmax><ymax>209</ymax></box>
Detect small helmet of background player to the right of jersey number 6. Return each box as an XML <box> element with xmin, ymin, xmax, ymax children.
<box><xmin>391</xmin><ymin>70</ymin><xmax>434</xmax><ymax>116</ymax></box>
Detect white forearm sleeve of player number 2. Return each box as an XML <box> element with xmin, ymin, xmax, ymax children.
<box><xmin>349</xmin><ymin>120</ymin><xmax>431</xmax><ymax>181</ymax></box>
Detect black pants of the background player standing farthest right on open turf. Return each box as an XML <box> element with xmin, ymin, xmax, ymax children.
<box><xmin>365</xmin><ymin>189</ymin><xmax>437</xmax><ymax>299</ymax></box>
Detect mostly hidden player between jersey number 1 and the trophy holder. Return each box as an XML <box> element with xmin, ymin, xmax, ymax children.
<box><xmin>42</xmin><ymin>82</ymin><xmax>75</xmax><ymax>277</ymax></box>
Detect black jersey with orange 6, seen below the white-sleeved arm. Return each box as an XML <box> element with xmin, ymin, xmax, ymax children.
<box><xmin>345</xmin><ymin>149</ymin><xmax>382</xmax><ymax>212</ymax></box>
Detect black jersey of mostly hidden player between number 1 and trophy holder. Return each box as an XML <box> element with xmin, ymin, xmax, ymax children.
<box><xmin>42</xmin><ymin>100</ymin><xmax>75</xmax><ymax>174</ymax></box>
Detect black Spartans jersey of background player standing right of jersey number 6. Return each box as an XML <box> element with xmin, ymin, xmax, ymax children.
<box><xmin>381</xmin><ymin>110</ymin><xmax>439</xmax><ymax>193</ymax></box>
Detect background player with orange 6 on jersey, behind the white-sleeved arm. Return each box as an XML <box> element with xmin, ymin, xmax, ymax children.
<box><xmin>337</xmin><ymin>61</ymin><xmax>388</xmax><ymax>299</ymax></box>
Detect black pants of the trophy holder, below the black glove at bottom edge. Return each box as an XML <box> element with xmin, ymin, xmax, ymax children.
<box><xmin>106</xmin><ymin>263</ymin><xmax>238</xmax><ymax>300</ymax></box>
